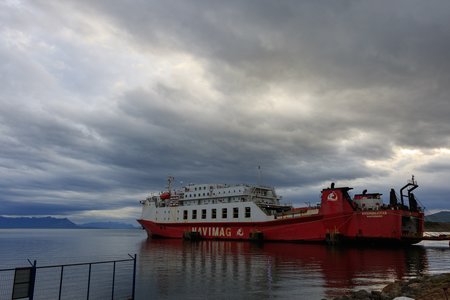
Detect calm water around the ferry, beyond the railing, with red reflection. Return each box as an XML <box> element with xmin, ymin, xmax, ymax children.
<box><xmin>0</xmin><ymin>229</ymin><xmax>450</xmax><ymax>299</ymax></box>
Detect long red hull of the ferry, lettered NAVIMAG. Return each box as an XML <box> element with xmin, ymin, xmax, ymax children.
<box><xmin>138</xmin><ymin>210</ymin><xmax>423</xmax><ymax>244</ymax></box>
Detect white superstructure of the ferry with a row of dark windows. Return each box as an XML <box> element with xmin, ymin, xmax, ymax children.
<box><xmin>141</xmin><ymin>177</ymin><xmax>291</xmax><ymax>223</ymax></box>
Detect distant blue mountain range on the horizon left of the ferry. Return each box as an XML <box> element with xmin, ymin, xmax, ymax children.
<box><xmin>0</xmin><ymin>216</ymin><xmax>137</xmax><ymax>229</ymax></box>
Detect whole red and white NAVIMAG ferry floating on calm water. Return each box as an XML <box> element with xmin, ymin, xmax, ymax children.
<box><xmin>137</xmin><ymin>176</ymin><xmax>424</xmax><ymax>244</ymax></box>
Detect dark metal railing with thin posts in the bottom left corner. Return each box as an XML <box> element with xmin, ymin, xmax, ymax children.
<box><xmin>0</xmin><ymin>254</ymin><xmax>136</xmax><ymax>300</ymax></box>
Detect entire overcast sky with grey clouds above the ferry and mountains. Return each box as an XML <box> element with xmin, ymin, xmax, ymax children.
<box><xmin>0</xmin><ymin>0</ymin><xmax>450</xmax><ymax>222</ymax></box>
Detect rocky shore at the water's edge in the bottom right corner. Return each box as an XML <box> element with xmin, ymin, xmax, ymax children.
<box><xmin>334</xmin><ymin>273</ymin><xmax>450</xmax><ymax>300</ymax></box>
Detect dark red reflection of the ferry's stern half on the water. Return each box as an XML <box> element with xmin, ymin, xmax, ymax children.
<box><xmin>263</xmin><ymin>244</ymin><xmax>427</xmax><ymax>297</ymax></box>
